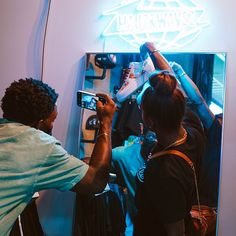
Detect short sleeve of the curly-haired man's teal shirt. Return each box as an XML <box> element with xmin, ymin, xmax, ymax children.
<box><xmin>35</xmin><ymin>143</ymin><xmax>89</xmax><ymax>191</ymax></box>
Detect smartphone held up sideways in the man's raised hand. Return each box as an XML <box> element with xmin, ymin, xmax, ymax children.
<box><xmin>77</xmin><ymin>90</ymin><xmax>106</xmax><ymax>111</ymax></box>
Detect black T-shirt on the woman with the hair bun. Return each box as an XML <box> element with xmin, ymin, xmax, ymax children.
<box><xmin>135</xmin><ymin>108</ymin><xmax>203</xmax><ymax>236</ymax></box>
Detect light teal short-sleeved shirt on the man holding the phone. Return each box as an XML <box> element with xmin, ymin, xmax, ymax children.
<box><xmin>0</xmin><ymin>119</ymin><xmax>88</xmax><ymax>235</ymax></box>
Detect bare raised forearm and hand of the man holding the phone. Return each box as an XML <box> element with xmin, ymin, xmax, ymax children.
<box><xmin>73</xmin><ymin>93</ymin><xmax>116</xmax><ymax>194</ymax></box>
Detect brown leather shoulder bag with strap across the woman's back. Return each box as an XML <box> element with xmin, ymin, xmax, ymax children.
<box><xmin>149</xmin><ymin>150</ymin><xmax>217</xmax><ymax>236</ymax></box>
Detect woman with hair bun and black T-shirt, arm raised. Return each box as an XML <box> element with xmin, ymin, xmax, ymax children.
<box><xmin>134</xmin><ymin>43</ymin><xmax>203</xmax><ymax>236</ymax></box>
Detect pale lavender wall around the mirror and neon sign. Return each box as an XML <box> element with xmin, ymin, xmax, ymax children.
<box><xmin>0</xmin><ymin>0</ymin><xmax>236</xmax><ymax>236</ymax></box>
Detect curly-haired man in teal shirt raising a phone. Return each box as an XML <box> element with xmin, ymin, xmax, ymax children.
<box><xmin>0</xmin><ymin>78</ymin><xmax>115</xmax><ymax>235</ymax></box>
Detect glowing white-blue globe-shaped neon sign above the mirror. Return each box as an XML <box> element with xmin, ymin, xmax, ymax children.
<box><xmin>102</xmin><ymin>0</ymin><xmax>210</xmax><ymax>50</ymax></box>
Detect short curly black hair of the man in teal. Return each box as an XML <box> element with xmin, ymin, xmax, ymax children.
<box><xmin>1</xmin><ymin>78</ymin><xmax>58</xmax><ymax>125</ymax></box>
